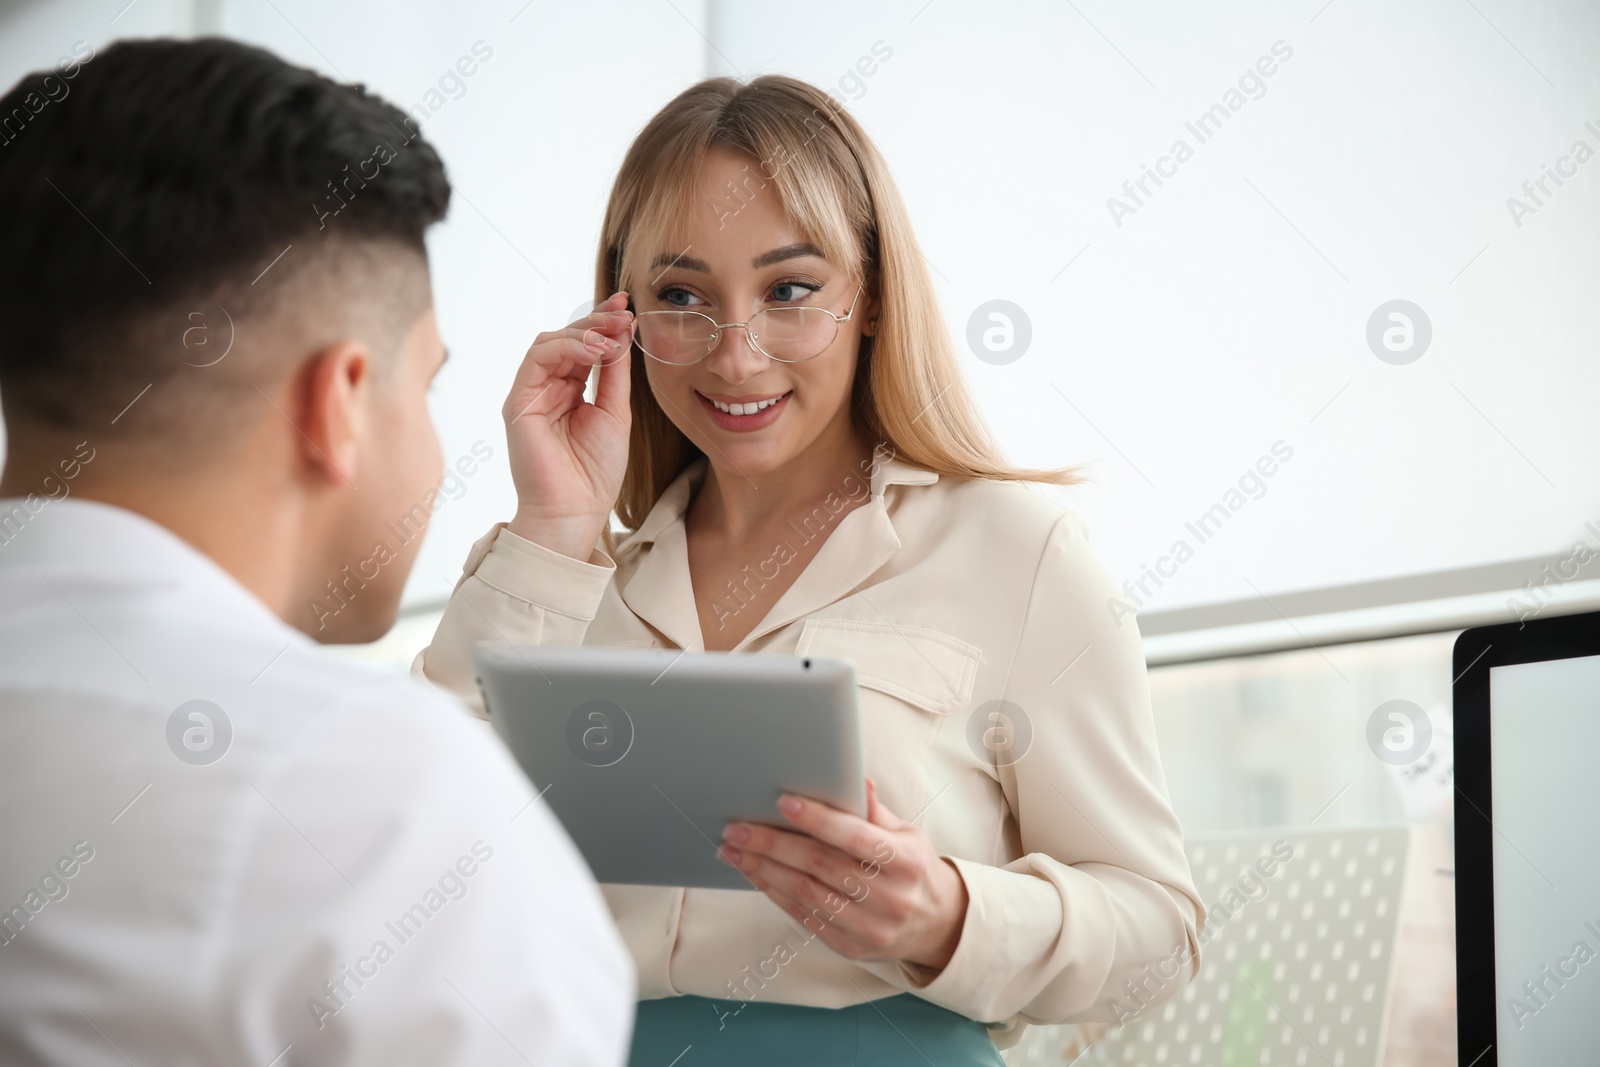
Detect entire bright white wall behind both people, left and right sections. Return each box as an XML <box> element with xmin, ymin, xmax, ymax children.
<box><xmin>0</xmin><ymin>0</ymin><xmax>1600</xmax><ymax>627</ymax></box>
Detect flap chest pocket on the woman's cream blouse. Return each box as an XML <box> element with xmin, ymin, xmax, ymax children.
<box><xmin>795</xmin><ymin>619</ymin><xmax>982</xmax><ymax>715</ymax></box>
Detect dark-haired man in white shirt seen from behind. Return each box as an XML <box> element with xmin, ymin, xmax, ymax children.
<box><xmin>0</xmin><ymin>38</ymin><xmax>634</xmax><ymax>1067</ymax></box>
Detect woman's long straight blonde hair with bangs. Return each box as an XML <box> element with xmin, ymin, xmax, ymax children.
<box><xmin>595</xmin><ymin>75</ymin><xmax>1083</xmax><ymax>530</ymax></box>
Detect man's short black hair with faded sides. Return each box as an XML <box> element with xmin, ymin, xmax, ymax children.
<box><xmin>0</xmin><ymin>37</ymin><xmax>450</xmax><ymax>432</ymax></box>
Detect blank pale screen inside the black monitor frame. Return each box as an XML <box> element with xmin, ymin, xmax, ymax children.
<box><xmin>1484</xmin><ymin>656</ymin><xmax>1600</xmax><ymax>1067</ymax></box>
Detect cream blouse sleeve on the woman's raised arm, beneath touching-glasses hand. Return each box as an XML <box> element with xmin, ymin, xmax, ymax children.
<box><xmin>411</xmin><ymin>523</ymin><xmax>616</xmax><ymax>718</ymax></box>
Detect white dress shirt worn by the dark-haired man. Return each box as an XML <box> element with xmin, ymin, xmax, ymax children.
<box><xmin>0</xmin><ymin>498</ymin><xmax>637</xmax><ymax>1067</ymax></box>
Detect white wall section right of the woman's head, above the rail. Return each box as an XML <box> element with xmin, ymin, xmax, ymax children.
<box><xmin>710</xmin><ymin>0</ymin><xmax>1600</xmax><ymax>609</ymax></box>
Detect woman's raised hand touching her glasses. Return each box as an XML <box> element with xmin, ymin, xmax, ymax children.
<box><xmin>501</xmin><ymin>293</ymin><xmax>634</xmax><ymax>560</ymax></box>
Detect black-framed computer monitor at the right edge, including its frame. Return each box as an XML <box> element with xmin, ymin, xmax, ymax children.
<box><xmin>1453</xmin><ymin>613</ymin><xmax>1600</xmax><ymax>1067</ymax></box>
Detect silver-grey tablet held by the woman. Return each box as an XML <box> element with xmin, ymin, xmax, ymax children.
<box><xmin>474</xmin><ymin>643</ymin><xmax>867</xmax><ymax>889</ymax></box>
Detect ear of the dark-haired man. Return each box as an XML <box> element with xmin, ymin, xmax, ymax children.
<box><xmin>293</xmin><ymin>341</ymin><xmax>373</xmax><ymax>486</ymax></box>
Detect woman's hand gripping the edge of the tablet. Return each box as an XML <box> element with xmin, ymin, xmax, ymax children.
<box><xmin>720</xmin><ymin>777</ymin><xmax>966</xmax><ymax>971</ymax></box>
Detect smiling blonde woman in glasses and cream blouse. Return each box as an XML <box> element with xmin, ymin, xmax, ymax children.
<box><xmin>416</xmin><ymin>77</ymin><xmax>1203</xmax><ymax>1067</ymax></box>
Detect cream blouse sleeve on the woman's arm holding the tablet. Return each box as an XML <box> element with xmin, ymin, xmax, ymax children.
<box><xmin>896</xmin><ymin>514</ymin><xmax>1205</xmax><ymax>1024</ymax></box>
